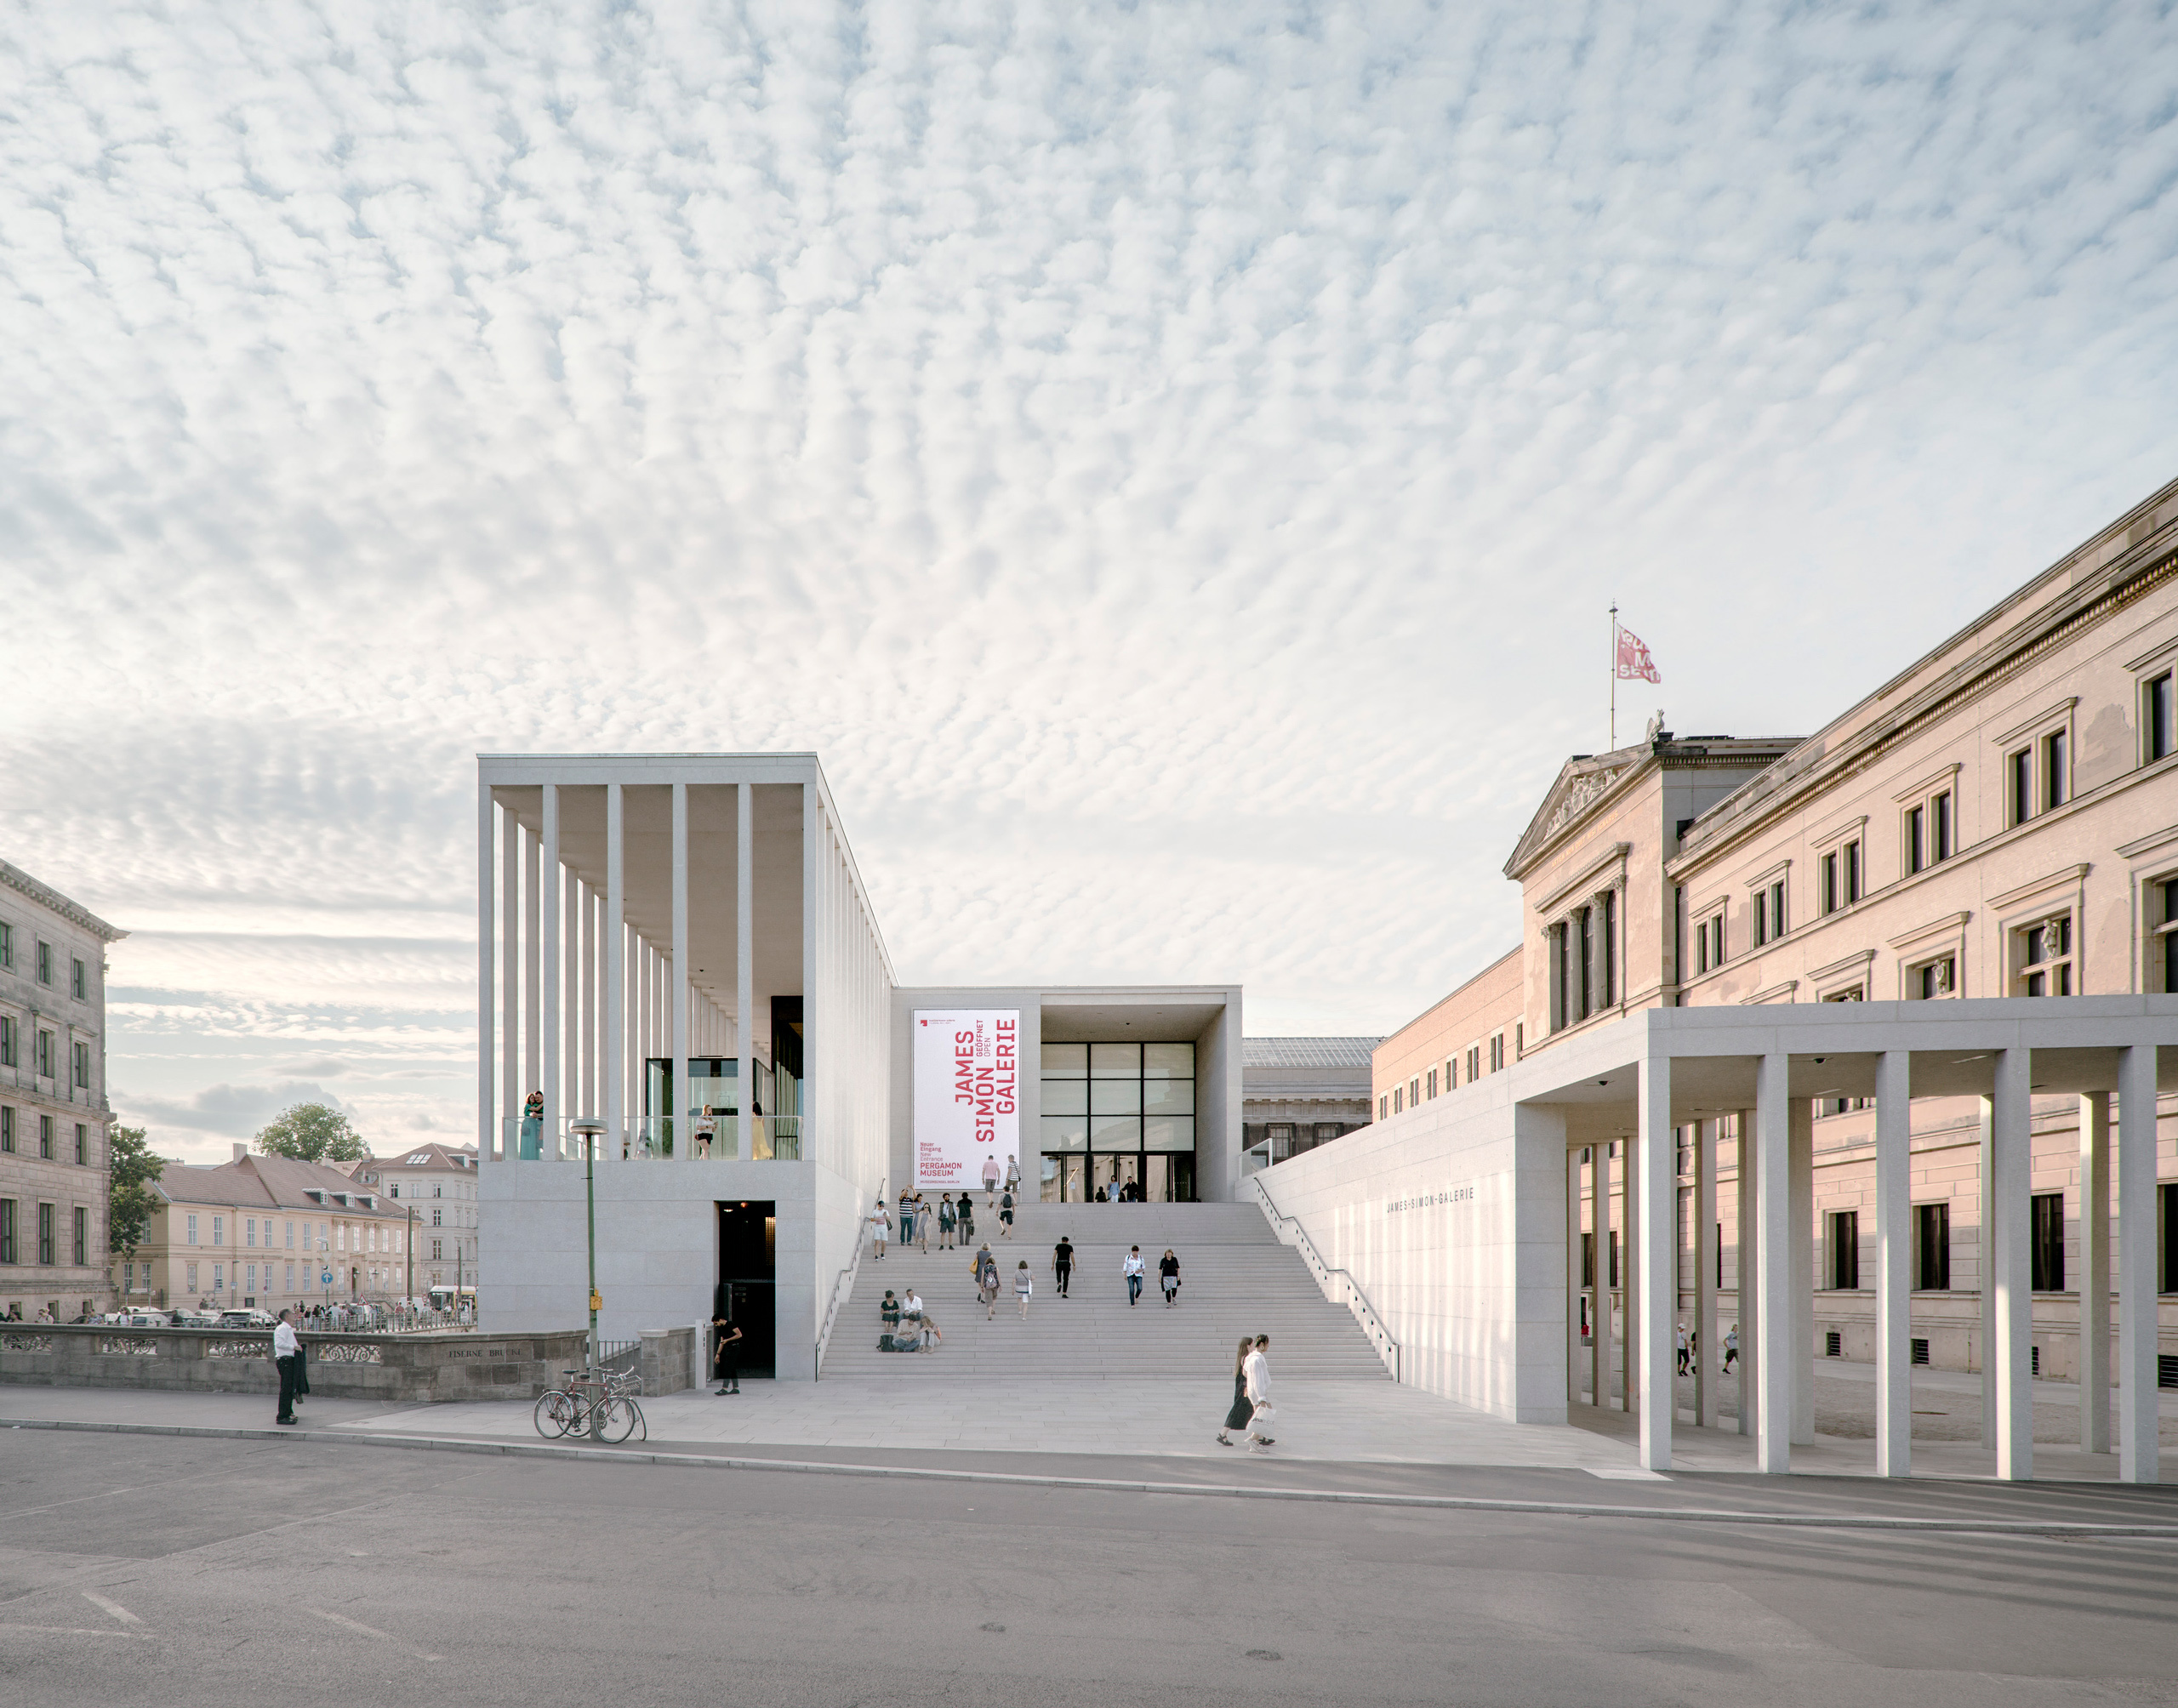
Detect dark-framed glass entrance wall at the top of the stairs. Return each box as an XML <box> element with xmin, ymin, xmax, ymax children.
<box><xmin>1041</xmin><ymin>1044</ymin><xmax>1195</xmax><ymax>1204</ymax></box>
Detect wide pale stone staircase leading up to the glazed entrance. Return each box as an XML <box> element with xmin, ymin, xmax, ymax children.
<box><xmin>824</xmin><ymin>1196</ymin><xmax>1388</xmax><ymax>1381</ymax></box>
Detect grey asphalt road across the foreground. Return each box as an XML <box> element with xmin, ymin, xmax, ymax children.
<box><xmin>0</xmin><ymin>1432</ymin><xmax>2178</xmax><ymax>1708</ymax></box>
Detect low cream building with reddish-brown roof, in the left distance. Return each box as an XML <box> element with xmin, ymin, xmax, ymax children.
<box><xmin>120</xmin><ymin>1146</ymin><xmax>409</xmax><ymax>1312</ymax></box>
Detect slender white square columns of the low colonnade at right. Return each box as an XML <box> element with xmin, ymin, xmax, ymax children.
<box><xmin>1566</xmin><ymin>1044</ymin><xmax>2158</xmax><ymax>1482</ymax></box>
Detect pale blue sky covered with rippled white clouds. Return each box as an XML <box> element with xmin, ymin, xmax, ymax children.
<box><xmin>0</xmin><ymin>0</ymin><xmax>2178</xmax><ymax>1157</ymax></box>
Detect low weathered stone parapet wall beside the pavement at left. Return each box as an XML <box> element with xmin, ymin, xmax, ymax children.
<box><xmin>0</xmin><ymin>1324</ymin><xmax>592</xmax><ymax>1405</ymax></box>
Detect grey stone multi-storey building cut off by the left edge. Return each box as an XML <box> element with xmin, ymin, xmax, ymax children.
<box><xmin>0</xmin><ymin>861</ymin><xmax>126</xmax><ymax>1320</ymax></box>
